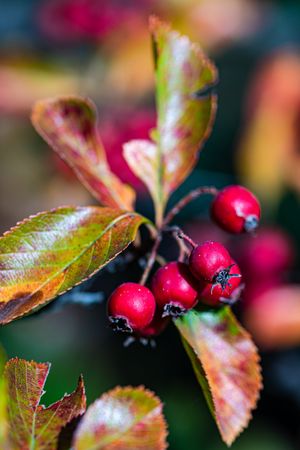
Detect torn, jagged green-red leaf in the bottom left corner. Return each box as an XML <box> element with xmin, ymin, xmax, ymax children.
<box><xmin>4</xmin><ymin>358</ymin><xmax>86</xmax><ymax>450</ymax></box>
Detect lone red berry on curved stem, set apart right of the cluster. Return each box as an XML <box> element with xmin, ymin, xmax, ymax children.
<box><xmin>211</xmin><ymin>185</ymin><xmax>261</xmax><ymax>233</ymax></box>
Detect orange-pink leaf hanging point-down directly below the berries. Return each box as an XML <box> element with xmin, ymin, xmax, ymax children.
<box><xmin>175</xmin><ymin>307</ymin><xmax>262</xmax><ymax>445</ymax></box>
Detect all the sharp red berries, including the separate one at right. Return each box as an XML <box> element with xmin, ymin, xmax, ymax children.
<box><xmin>108</xmin><ymin>186</ymin><xmax>260</xmax><ymax>339</ymax></box>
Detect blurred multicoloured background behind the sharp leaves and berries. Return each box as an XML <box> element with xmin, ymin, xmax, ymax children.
<box><xmin>0</xmin><ymin>0</ymin><xmax>300</xmax><ymax>450</ymax></box>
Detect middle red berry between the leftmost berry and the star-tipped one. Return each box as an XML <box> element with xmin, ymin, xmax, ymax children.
<box><xmin>152</xmin><ymin>261</ymin><xmax>197</xmax><ymax>317</ymax></box>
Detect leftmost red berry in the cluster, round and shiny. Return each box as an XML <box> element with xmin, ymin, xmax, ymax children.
<box><xmin>107</xmin><ymin>283</ymin><xmax>156</xmax><ymax>332</ymax></box>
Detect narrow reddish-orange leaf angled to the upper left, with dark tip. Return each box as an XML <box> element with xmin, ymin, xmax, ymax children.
<box><xmin>32</xmin><ymin>97</ymin><xmax>135</xmax><ymax>210</ymax></box>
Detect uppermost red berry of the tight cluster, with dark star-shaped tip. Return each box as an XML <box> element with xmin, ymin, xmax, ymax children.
<box><xmin>189</xmin><ymin>241</ymin><xmax>231</xmax><ymax>282</ymax></box>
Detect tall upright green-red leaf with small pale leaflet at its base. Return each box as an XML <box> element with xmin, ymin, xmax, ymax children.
<box><xmin>125</xmin><ymin>17</ymin><xmax>217</xmax><ymax>223</ymax></box>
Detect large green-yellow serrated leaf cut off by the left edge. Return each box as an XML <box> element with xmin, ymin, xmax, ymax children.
<box><xmin>0</xmin><ymin>206</ymin><xmax>146</xmax><ymax>324</ymax></box>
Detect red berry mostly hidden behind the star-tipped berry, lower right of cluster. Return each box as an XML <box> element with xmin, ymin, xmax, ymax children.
<box><xmin>198</xmin><ymin>261</ymin><xmax>242</xmax><ymax>306</ymax></box>
